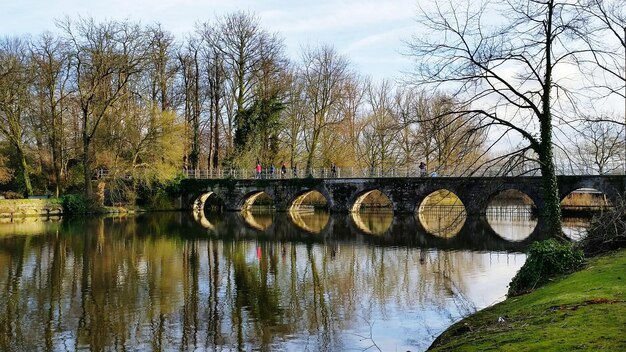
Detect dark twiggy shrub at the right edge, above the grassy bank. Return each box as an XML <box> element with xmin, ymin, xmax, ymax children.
<box><xmin>578</xmin><ymin>199</ymin><xmax>626</xmax><ymax>257</ymax></box>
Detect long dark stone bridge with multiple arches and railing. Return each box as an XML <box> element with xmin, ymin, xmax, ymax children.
<box><xmin>180</xmin><ymin>175</ymin><xmax>626</xmax><ymax>216</ymax></box>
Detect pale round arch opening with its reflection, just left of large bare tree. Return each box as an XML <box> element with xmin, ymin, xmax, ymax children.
<box><xmin>485</xmin><ymin>189</ymin><xmax>538</xmax><ymax>241</ymax></box>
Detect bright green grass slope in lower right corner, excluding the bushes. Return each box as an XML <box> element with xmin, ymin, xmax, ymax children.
<box><xmin>429</xmin><ymin>250</ymin><xmax>626</xmax><ymax>351</ymax></box>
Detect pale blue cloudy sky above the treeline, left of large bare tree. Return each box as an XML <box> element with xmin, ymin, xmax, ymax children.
<box><xmin>0</xmin><ymin>0</ymin><xmax>417</xmax><ymax>79</ymax></box>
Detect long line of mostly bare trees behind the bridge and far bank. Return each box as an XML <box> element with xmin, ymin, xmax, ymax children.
<box><xmin>0</xmin><ymin>12</ymin><xmax>486</xmax><ymax>201</ymax></box>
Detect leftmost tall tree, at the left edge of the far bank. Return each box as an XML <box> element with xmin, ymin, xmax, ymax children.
<box><xmin>0</xmin><ymin>38</ymin><xmax>33</xmax><ymax>196</ymax></box>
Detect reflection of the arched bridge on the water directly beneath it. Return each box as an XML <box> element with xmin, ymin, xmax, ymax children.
<box><xmin>194</xmin><ymin>206</ymin><xmax>588</xmax><ymax>251</ymax></box>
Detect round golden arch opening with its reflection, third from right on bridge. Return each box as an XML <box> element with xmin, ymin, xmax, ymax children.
<box><xmin>418</xmin><ymin>189</ymin><xmax>467</xmax><ymax>238</ymax></box>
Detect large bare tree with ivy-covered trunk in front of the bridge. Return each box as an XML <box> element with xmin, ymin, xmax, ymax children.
<box><xmin>409</xmin><ymin>0</ymin><xmax>596</xmax><ymax>236</ymax></box>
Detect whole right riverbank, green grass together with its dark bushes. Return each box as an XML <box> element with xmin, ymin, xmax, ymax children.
<box><xmin>429</xmin><ymin>202</ymin><xmax>626</xmax><ymax>351</ymax></box>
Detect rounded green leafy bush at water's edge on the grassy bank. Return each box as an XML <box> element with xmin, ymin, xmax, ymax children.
<box><xmin>507</xmin><ymin>239</ymin><xmax>584</xmax><ymax>297</ymax></box>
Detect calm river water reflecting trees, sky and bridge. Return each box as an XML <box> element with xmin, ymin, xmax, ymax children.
<box><xmin>0</xmin><ymin>207</ymin><xmax>585</xmax><ymax>351</ymax></box>
